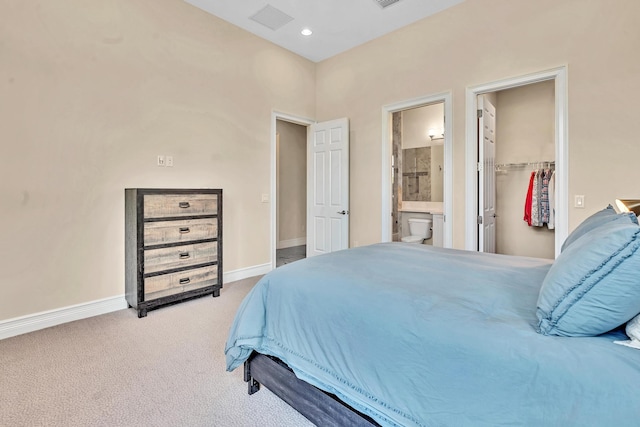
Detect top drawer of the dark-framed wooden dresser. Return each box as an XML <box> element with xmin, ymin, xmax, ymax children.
<box><xmin>144</xmin><ymin>194</ymin><xmax>218</xmax><ymax>218</ymax></box>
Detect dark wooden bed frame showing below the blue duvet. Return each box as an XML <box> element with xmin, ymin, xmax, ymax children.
<box><xmin>244</xmin><ymin>352</ymin><xmax>380</xmax><ymax>427</ymax></box>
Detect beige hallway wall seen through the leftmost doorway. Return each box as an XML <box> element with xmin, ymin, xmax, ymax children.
<box><xmin>276</xmin><ymin>120</ymin><xmax>307</xmax><ymax>248</ymax></box>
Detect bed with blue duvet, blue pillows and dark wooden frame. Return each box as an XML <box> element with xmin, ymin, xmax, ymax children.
<box><xmin>225</xmin><ymin>208</ymin><xmax>640</xmax><ymax>426</ymax></box>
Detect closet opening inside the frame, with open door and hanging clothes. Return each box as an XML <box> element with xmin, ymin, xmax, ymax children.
<box><xmin>478</xmin><ymin>80</ymin><xmax>555</xmax><ymax>259</ymax></box>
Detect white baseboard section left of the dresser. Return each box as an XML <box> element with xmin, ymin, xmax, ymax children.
<box><xmin>0</xmin><ymin>295</ymin><xmax>128</xmax><ymax>340</ymax></box>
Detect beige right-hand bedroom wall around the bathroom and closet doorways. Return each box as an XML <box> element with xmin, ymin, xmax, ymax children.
<box><xmin>316</xmin><ymin>0</ymin><xmax>640</xmax><ymax>248</ymax></box>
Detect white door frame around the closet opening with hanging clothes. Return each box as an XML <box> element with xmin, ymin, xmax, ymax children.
<box><xmin>465</xmin><ymin>65</ymin><xmax>569</xmax><ymax>258</ymax></box>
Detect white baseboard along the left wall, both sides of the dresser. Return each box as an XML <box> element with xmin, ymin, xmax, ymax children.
<box><xmin>0</xmin><ymin>263</ymin><xmax>271</xmax><ymax>340</ymax></box>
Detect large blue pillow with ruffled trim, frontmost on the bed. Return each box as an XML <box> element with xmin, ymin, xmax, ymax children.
<box><xmin>536</xmin><ymin>221</ymin><xmax>640</xmax><ymax>337</ymax></box>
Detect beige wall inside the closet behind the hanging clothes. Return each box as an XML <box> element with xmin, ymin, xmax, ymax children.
<box><xmin>495</xmin><ymin>81</ymin><xmax>555</xmax><ymax>259</ymax></box>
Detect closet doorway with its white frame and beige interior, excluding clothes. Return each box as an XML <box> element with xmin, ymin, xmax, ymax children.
<box><xmin>465</xmin><ymin>67</ymin><xmax>568</xmax><ymax>258</ymax></box>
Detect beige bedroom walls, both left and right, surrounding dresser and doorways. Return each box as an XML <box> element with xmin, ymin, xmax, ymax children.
<box><xmin>0</xmin><ymin>0</ymin><xmax>640</xmax><ymax>320</ymax></box>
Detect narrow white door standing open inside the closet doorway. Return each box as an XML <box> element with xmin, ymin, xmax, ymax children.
<box><xmin>478</xmin><ymin>96</ymin><xmax>496</xmax><ymax>253</ymax></box>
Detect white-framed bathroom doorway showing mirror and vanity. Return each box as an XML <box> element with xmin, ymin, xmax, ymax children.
<box><xmin>382</xmin><ymin>93</ymin><xmax>453</xmax><ymax>247</ymax></box>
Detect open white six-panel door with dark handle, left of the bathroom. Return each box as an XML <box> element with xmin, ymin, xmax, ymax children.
<box><xmin>307</xmin><ymin>118</ymin><xmax>349</xmax><ymax>257</ymax></box>
